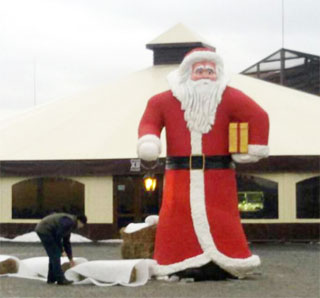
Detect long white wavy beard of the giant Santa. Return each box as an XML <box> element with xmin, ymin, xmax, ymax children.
<box><xmin>178</xmin><ymin>79</ymin><xmax>221</xmax><ymax>134</ymax></box>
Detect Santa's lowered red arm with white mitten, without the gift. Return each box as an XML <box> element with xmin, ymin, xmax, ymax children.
<box><xmin>137</xmin><ymin>96</ymin><xmax>164</xmax><ymax>161</ymax></box>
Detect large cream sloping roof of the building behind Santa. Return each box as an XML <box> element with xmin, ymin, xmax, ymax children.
<box><xmin>0</xmin><ymin>25</ymin><xmax>320</xmax><ymax>161</ymax></box>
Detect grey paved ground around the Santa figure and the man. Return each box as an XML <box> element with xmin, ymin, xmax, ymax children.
<box><xmin>0</xmin><ymin>243</ymin><xmax>320</xmax><ymax>298</ymax></box>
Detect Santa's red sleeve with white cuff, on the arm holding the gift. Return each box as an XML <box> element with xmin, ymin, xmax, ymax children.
<box><xmin>227</xmin><ymin>88</ymin><xmax>269</xmax><ymax>158</ymax></box>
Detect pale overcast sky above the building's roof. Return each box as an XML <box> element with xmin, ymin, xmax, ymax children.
<box><xmin>0</xmin><ymin>0</ymin><xmax>320</xmax><ymax>110</ymax></box>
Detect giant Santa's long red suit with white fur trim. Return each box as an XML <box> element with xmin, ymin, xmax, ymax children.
<box><xmin>138</xmin><ymin>47</ymin><xmax>269</xmax><ymax>277</ymax></box>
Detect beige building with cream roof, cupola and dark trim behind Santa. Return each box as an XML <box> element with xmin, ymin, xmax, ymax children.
<box><xmin>0</xmin><ymin>24</ymin><xmax>320</xmax><ymax>240</ymax></box>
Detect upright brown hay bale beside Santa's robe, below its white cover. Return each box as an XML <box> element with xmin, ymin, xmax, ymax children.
<box><xmin>120</xmin><ymin>225</ymin><xmax>157</xmax><ymax>259</ymax></box>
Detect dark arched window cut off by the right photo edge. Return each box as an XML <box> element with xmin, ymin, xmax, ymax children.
<box><xmin>296</xmin><ymin>176</ymin><xmax>320</xmax><ymax>218</ymax></box>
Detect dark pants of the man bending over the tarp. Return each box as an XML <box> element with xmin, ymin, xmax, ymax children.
<box><xmin>37</xmin><ymin>233</ymin><xmax>65</xmax><ymax>283</ymax></box>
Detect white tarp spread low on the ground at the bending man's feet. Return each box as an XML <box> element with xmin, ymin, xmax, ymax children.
<box><xmin>0</xmin><ymin>255</ymin><xmax>156</xmax><ymax>287</ymax></box>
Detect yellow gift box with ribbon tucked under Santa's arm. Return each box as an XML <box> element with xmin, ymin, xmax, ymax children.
<box><xmin>229</xmin><ymin>122</ymin><xmax>249</xmax><ymax>153</ymax></box>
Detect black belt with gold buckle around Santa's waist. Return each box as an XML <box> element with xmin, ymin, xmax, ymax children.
<box><xmin>166</xmin><ymin>155</ymin><xmax>233</xmax><ymax>170</ymax></box>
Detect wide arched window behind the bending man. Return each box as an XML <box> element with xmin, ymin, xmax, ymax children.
<box><xmin>12</xmin><ymin>178</ymin><xmax>84</xmax><ymax>219</ymax></box>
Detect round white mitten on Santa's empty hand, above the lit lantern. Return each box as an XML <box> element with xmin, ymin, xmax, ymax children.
<box><xmin>137</xmin><ymin>135</ymin><xmax>161</xmax><ymax>161</ymax></box>
